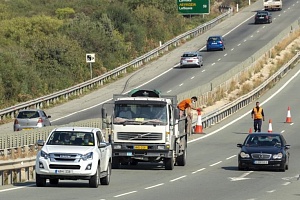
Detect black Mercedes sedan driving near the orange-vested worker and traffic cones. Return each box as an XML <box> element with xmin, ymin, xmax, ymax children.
<box><xmin>237</xmin><ymin>133</ymin><xmax>290</xmax><ymax>172</ymax></box>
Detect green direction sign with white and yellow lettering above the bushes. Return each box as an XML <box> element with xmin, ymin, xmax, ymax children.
<box><xmin>177</xmin><ymin>0</ymin><xmax>210</xmax><ymax>15</ymax></box>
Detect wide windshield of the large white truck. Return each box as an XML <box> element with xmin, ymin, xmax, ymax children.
<box><xmin>114</xmin><ymin>104</ymin><xmax>167</xmax><ymax>125</ymax></box>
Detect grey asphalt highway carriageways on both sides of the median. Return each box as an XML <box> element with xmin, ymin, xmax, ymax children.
<box><xmin>0</xmin><ymin>1</ymin><xmax>300</xmax><ymax>200</ymax></box>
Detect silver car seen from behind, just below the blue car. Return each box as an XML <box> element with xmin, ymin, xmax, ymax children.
<box><xmin>180</xmin><ymin>51</ymin><xmax>203</xmax><ymax>67</ymax></box>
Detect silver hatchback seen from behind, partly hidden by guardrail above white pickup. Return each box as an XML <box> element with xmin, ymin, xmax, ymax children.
<box><xmin>14</xmin><ymin>109</ymin><xmax>51</xmax><ymax>131</ymax></box>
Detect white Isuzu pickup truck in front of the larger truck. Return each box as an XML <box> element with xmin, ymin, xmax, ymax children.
<box><xmin>35</xmin><ymin>127</ymin><xmax>112</xmax><ymax>188</ymax></box>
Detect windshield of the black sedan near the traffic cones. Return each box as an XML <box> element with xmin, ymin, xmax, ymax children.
<box><xmin>244</xmin><ymin>134</ymin><xmax>282</xmax><ymax>147</ymax></box>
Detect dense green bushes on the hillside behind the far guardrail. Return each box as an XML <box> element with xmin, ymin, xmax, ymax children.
<box><xmin>0</xmin><ymin>0</ymin><xmax>246</xmax><ymax>109</ymax></box>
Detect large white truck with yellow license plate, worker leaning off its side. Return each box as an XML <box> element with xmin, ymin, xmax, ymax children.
<box><xmin>103</xmin><ymin>89</ymin><xmax>187</xmax><ymax>170</ymax></box>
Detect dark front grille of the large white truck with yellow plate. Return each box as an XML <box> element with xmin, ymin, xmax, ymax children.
<box><xmin>117</xmin><ymin>132</ymin><xmax>162</xmax><ymax>141</ymax></box>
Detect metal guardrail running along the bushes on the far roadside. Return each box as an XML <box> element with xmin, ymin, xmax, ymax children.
<box><xmin>0</xmin><ymin>9</ymin><xmax>232</xmax><ymax>120</ymax></box>
